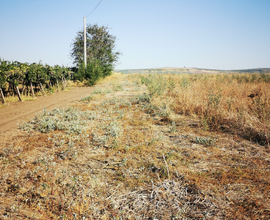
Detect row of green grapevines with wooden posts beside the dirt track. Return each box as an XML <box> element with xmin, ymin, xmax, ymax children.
<box><xmin>0</xmin><ymin>59</ymin><xmax>73</xmax><ymax>103</ymax></box>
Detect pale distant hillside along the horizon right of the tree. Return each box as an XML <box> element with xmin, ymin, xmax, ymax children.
<box><xmin>115</xmin><ymin>67</ymin><xmax>270</xmax><ymax>74</ymax></box>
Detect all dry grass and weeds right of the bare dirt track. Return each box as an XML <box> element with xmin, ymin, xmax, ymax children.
<box><xmin>0</xmin><ymin>74</ymin><xmax>270</xmax><ymax>219</ymax></box>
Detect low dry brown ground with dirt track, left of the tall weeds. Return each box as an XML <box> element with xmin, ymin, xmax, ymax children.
<box><xmin>0</xmin><ymin>74</ymin><xmax>270</xmax><ymax>220</ymax></box>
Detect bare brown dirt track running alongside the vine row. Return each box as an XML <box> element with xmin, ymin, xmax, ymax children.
<box><xmin>0</xmin><ymin>87</ymin><xmax>94</xmax><ymax>144</ymax></box>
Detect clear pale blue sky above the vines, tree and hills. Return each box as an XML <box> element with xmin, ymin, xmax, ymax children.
<box><xmin>0</xmin><ymin>0</ymin><xmax>270</xmax><ymax>69</ymax></box>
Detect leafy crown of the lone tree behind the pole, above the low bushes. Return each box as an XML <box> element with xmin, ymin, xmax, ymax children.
<box><xmin>70</xmin><ymin>24</ymin><xmax>120</xmax><ymax>75</ymax></box>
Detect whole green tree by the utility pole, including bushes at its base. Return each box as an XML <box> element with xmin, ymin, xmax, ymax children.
<box><xmin>71</xmin><ymin>24</ymin><xmax>120</xmax><ymax>86</ymax></box>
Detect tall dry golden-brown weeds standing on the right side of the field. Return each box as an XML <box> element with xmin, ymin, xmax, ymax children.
<box><xmin>135</xmin><ymin>74</ymin><xmax>270</xmax><ymax>145</ymax></box>
